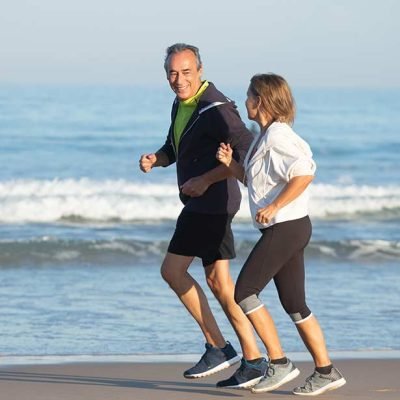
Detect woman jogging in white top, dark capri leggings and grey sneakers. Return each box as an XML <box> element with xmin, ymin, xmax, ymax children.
<box><xmin>217</xmin><ymin>74</ymin><xmax>346</xmax><ymax>396</ymax></box>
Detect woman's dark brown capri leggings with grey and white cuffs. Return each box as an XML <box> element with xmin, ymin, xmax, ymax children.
<box><xmin>235</xmin><ymin>216</ymin><xmax>312</xmax><ymax>323</ymax></box>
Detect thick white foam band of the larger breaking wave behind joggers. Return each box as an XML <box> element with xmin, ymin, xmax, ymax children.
<box><xmin>0</xmin><ymin>178</ymin><xmax>400</xmax><ymax>224</ymax></box>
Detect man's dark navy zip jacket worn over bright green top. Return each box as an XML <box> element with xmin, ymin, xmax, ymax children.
<box><xmin>158</xmin><ymin>82</ymin><xmax>252</xmax><ymax>214</ymax></box>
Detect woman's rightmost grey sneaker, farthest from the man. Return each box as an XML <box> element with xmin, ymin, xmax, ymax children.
<box><xmin>293</xmin><ymin>368</ymin><xmax>346</xmax><ymax>396</ymax></box>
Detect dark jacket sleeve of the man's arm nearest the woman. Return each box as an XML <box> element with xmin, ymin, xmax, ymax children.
<box><xmin>212</xmin><ymin>103</ymin><xmax>253</xmax><ymax>164</ymax></box>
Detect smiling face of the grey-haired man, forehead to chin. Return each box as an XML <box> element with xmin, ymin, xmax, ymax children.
<box><xmin>167</xmin><ymin>50</ymin><xmax>203</xmax><ymax>100</ymax></box>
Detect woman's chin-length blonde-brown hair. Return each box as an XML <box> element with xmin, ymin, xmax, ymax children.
<box><xmin>249</xmin><ymin>74</ymin><xmax>296</xmax><ymax>125</ymax></box>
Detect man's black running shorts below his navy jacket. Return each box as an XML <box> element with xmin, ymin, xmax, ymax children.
<box><xmin>168</xmin><ymin>211</ymin><xmax>236</xmax><ymax>267</ymax></box>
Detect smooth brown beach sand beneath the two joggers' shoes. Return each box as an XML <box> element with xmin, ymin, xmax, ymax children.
<box><xmin>0</xmin><ymin>359</ymin><xmax>400</xmax><ymax>400</ymax></box>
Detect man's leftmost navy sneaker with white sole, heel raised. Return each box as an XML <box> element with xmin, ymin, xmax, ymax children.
<box><xmin>183</xmin><ymin>342</ymin><xmax>240</xmax><ymax>379</ymax></box>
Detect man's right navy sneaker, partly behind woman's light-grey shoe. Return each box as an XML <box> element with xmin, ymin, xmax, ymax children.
<box><xmin>217</xmin><ymin>358</ymin><xmax>268</xmax><ymax>389</ymax></box>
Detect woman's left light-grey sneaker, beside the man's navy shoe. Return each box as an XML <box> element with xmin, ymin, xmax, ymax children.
<box><xmin>251</xmin><ymin>359</ymin><xmax>300</xmax><ymax>393</ymax></box>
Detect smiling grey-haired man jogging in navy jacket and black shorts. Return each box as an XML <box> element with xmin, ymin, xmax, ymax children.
<box><xmin>139</xmin><ymin>43</ymin><xmax>267</xmax><ymax>387</ymax></box>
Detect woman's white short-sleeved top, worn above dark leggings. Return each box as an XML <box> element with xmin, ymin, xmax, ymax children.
<box><xmin>244</xmin><ymin>122</ymin><xmax>316</xmax><ymax>229</ymax></box>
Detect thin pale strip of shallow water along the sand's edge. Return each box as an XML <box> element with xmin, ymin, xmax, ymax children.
<box><xmin>0</xmin><ymin>349</ymin><xmax>400</xmax><ymax>368</ymax></box>
